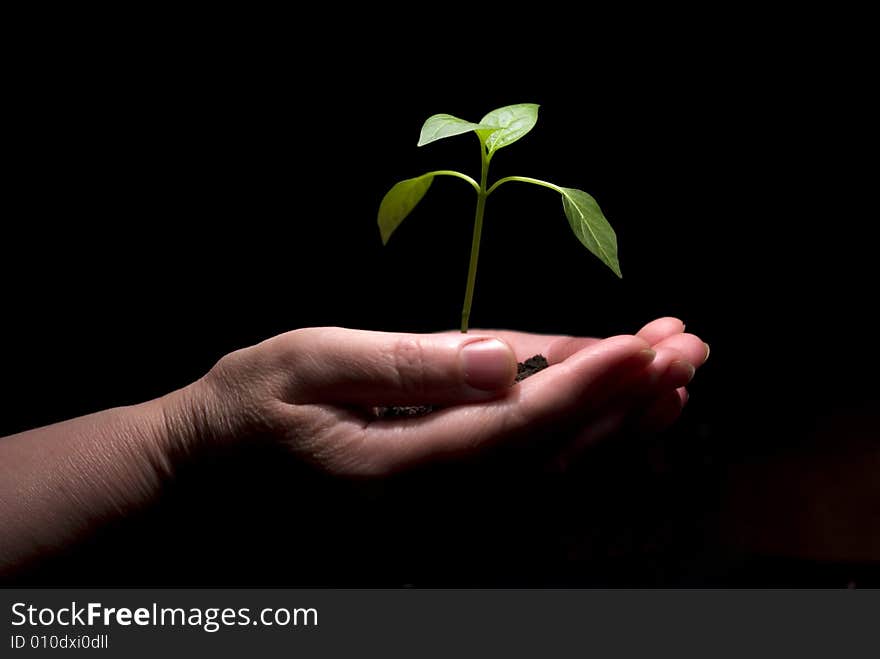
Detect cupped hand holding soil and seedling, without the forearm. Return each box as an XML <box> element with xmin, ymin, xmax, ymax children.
<box><xmin>191</xmin><ymin>318</ymin><xmax>708</xmax><ymax>476</ymax></box>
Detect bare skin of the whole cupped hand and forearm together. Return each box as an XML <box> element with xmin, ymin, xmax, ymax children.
<box><xmin>0</xmin><ymin>318</ymin><xmax>708</xmax><ymax>576</ymax></box>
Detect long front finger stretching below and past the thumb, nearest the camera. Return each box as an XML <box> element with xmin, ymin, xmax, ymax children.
<box><xmin>366</xmin><ymin>336</ymin><xmax>654</xmax><ymax>470</ymax></box>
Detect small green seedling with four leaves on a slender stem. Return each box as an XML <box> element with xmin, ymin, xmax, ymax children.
<box><xmin>379</xmin><ymin>103</ymin><xmax>621</xmax><ymax>332</ymax></box>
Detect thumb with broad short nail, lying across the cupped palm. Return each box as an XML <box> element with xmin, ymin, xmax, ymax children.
<box><xmin>286</xmin><ymin>327</ymin><xmax>516</xmax><ymax>405</ymax></box>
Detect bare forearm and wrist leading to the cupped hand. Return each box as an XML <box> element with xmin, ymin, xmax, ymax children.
<box><xmin>0</xmin><ymin>385</ymin><xmax>205</xmax><ymax>576</ymax></box>
